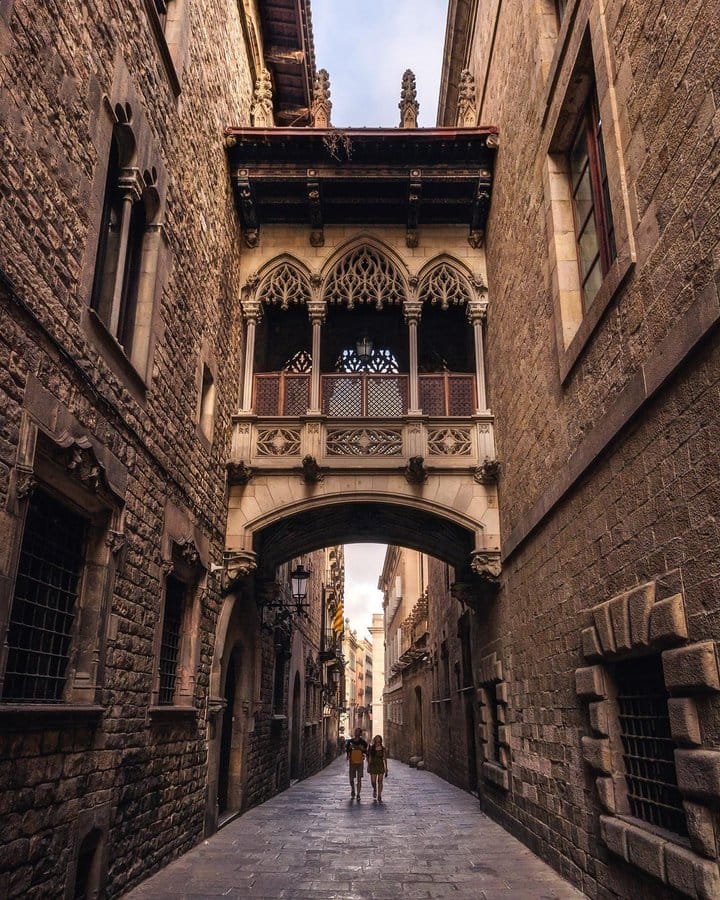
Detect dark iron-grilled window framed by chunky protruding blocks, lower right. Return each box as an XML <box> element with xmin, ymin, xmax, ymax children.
<box><xmin>612</xmin><ymin>656</ymin><xmax>687</xmax><ymax>834</ymax></box>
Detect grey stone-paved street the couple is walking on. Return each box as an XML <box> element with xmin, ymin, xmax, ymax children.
<box><xmin>126</xmin><ymin>759</ymin><xmax>584</xmax><ymax>900</ymax></box>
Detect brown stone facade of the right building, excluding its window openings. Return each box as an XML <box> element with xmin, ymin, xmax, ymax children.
<box><xmin>439</xmin><ymin>0</ymin><xmax>720</xmax><ymax>897</ymax></box>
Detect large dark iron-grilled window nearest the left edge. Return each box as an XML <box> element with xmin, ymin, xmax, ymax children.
<box><xmin>2</xmin><ymin>491</ymin><xmax>87</xmax><ymax>703</ymax></box>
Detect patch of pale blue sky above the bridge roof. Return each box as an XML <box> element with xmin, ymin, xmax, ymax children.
<box><xmin>312</xmin><ymin>0</ymin><xmax>448</xmax><ymax>127</ymax></box>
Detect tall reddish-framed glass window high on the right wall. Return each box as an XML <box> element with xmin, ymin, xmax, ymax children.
<box><xmin>569</xmin><ymin>88</ymin><xmax>616</xmax><ymax>310</ymax></box>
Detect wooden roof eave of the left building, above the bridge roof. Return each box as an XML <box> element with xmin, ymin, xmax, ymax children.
<box><xmin>260</xmin><ymin>0</ymin><xmax>315</xmax><ymax>126</ymax></box>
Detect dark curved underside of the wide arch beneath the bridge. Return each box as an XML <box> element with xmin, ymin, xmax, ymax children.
<box><xmin>254</xmin><ymin>502</ymin><xmax>475</xmax><ymax>574</ymax></box>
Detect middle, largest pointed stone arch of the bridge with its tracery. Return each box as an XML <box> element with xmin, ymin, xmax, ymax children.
<box><xmin>322</xmin><ymin>235</ymin><xmax>408</xmax><ymax>309</ymax></box>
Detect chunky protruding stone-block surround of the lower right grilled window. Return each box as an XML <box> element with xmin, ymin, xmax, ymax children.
<box><xmin>575</xmin><ymin>573</ymin><xmax>720</xmax><ymax>898</ymax></box>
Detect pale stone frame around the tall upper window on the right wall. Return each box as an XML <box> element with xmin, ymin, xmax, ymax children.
<box><xmin>543</xmin><ymin>20</ymin><xmax>636</xmax><ymax>383</ymax></box>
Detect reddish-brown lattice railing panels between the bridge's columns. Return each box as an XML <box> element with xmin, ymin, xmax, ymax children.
<box><xmin>253</xmin><ymin>372</ymin><xmax>476</xmax><ymax>419</ymax></box>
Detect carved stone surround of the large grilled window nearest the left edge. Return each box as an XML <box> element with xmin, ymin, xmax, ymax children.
<box><xmin>0</xmin><ymin>418</ymin><xmax>127</xmax><ymax>730</ymax></box>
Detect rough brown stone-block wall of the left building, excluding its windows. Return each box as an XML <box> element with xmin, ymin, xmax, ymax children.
<box><xmin>0</xmin><ymin>0</ymin><xmax>253</xmax><ymax>898</ymax></box>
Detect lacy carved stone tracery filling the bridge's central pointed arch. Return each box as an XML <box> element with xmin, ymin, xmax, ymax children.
<box><xmin>325</xmin><ymin>244</ymin><xmax>405</xmax><ymax>310</ymax></box>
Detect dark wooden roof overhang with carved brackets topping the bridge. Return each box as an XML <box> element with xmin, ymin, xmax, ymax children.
<box><xmin>226</xmin><ymin>128</ymin><xmax>498</xmax><ymax>247</ymax></box>
